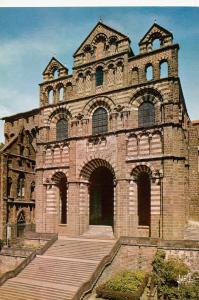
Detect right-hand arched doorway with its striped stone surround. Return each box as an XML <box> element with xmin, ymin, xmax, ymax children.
<box><xmin>129</xmin><ymin>165</ymin><xmax>161</xmax><ymax>237</ymax></box>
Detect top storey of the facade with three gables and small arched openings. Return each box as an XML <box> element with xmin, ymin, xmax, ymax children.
<box><xmin>40</xmin><ymin>22</ymin><xmax>179</xmax><ymax>107</ymax></box>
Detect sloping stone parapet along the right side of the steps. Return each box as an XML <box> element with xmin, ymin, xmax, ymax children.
<box><xmin>72</xmin><ymin>240</ymin><xmax>121</xmax><ymax>300</ymax></box>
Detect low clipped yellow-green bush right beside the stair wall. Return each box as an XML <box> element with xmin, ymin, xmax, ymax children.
<box><xmin>96</xmin><ymin>271</ymin><xmax>148</xmax><ymax>300</ymax></box>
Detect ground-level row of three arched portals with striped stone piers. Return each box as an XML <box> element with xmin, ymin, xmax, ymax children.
<box><xmin>40</xmin><ymin>159</ymin><xmax>161</xmax><ymax>238</ymax></box>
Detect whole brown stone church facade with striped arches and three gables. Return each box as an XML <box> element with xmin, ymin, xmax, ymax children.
<box><xmin>1</xmin><ymin>22</ymin><xmax>199</xmax><ymax>239</ymax></box>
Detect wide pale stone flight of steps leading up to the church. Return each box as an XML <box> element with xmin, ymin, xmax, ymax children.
<box><xmin>0</xmin><ymin>237</ymin><xmax>115</xmax><ymax>300</ymax></box>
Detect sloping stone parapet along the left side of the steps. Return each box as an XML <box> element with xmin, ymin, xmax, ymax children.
<box><xmin>0</xmin><ymin>235</ymin><xmax>58</xmax><ymax>286</ymax></box>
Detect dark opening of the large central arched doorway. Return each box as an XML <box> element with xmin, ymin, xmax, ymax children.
<box><xmin>89</xmin><ymin>166</ymin><xmax>114</xmax><ymax>226</ymax></box>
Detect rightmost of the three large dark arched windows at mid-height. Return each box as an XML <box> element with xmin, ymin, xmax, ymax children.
<box><xmin>138</xmin><ymin>102</ymin><xmax>155</xmax><ymax>127</ymax></box>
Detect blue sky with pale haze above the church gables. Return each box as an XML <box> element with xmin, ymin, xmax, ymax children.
<box><xmin>0</xmin><ymin>7</ymin><xmax>199</xmax><ymax>141</ymax></box>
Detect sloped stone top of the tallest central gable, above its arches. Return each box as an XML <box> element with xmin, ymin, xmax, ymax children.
<box><xmin>73</xmin><ymin>21</ymin><xmax>129</xmax><ymax>56</ymax></box>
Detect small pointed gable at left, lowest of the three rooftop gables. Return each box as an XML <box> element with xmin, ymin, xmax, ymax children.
<box><xmin>42</xmin><ymin>57</ymin><xmax>68</xmax><ymax>80</ymax></box>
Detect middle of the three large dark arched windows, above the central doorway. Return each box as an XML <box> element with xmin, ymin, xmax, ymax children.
<box><xmin>92</xmin><ymin>107</ymin><xmax>108</xmax><ymax>134</ymax></box>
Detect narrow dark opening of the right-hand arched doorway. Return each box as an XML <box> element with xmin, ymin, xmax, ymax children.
<box><xmin>137</xmin><ymin>172</ymin><xmax>151</xmax><ymax>226</ymax></box>
